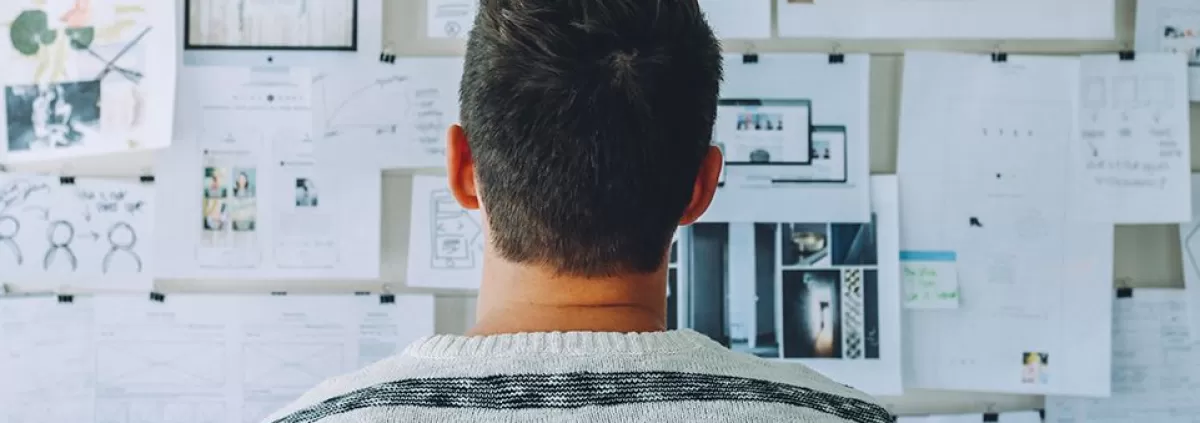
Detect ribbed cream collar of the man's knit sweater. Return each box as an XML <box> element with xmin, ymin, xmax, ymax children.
<box><xmin>404</xmin><ymin>329</ymin><xmax>716</xmax><ymax>358</ymax></box>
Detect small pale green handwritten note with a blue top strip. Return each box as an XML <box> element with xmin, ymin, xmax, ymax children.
<box><xmin>900</xmin><ymin>251</ymin><xmax>959</xmax><ymax>309</ymax></box>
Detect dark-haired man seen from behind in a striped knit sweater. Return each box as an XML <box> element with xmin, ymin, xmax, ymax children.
<box><xmin>269</xmin><ymin>0</ymin><xmax>890</xmax><ymax>423</ymax></box>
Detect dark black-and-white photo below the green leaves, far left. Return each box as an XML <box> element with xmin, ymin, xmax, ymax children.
<box><xmin>5</xmin><ymin>81</ymin><xmax>101</xmax><ymax>151</ymax></box>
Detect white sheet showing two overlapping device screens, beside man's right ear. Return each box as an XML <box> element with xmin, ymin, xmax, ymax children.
<box><xmin>701</xmin><ymin>54</ymin><xmax>870</xmax><ymax>222</ymax></box>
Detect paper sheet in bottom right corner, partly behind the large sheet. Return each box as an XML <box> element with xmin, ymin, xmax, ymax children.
<box><xmin>1046</xmin><ymin>288</ymin><xmax>1200</xmax><ymax>423</ymax></box>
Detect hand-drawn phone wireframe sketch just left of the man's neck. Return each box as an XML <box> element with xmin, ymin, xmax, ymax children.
<box><xmin>430</xmin><ymin>190</ymin><xmax>484</xmax><ymax>269</ymax></box>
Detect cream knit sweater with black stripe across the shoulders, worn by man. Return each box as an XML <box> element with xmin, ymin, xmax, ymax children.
<box><xmin>264</xmin><ymin>330</ymin><xmax>892</xmax><ymax>423</ymax></box>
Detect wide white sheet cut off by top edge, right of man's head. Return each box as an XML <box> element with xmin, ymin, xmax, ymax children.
<box><xmin>776</xmin><ymin>0</ymin><xmax>1116</xmax><ymax>40</ymax></box>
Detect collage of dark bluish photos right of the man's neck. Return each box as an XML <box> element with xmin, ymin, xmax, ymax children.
<box><xmin>667</xmin><ymin>216</ymin><xmax>881</xmax><ymax>359</ymax></box>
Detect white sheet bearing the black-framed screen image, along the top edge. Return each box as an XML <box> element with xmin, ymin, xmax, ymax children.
<box><xmin>176</xmin><ymin>0</ymin><xmax>384</xmax><ymax>67</ymax></box>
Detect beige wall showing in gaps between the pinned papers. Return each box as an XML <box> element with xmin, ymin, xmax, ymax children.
<box><xmin>158</xmin><ymin>0</ymin><xmax>1200</xmax><ymax>413</ymax></box>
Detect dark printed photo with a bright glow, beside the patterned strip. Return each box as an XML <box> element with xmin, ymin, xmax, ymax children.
<box><xmin>782</xmin><ymin>270</ymin><xmax>842</xmax><ymax>358</ymax></box>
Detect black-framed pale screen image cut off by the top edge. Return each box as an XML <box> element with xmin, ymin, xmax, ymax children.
<box><xmin>184</xmin><ymin>0</ymin><xmax>359</xmax><ymax>52</ymax></box>
